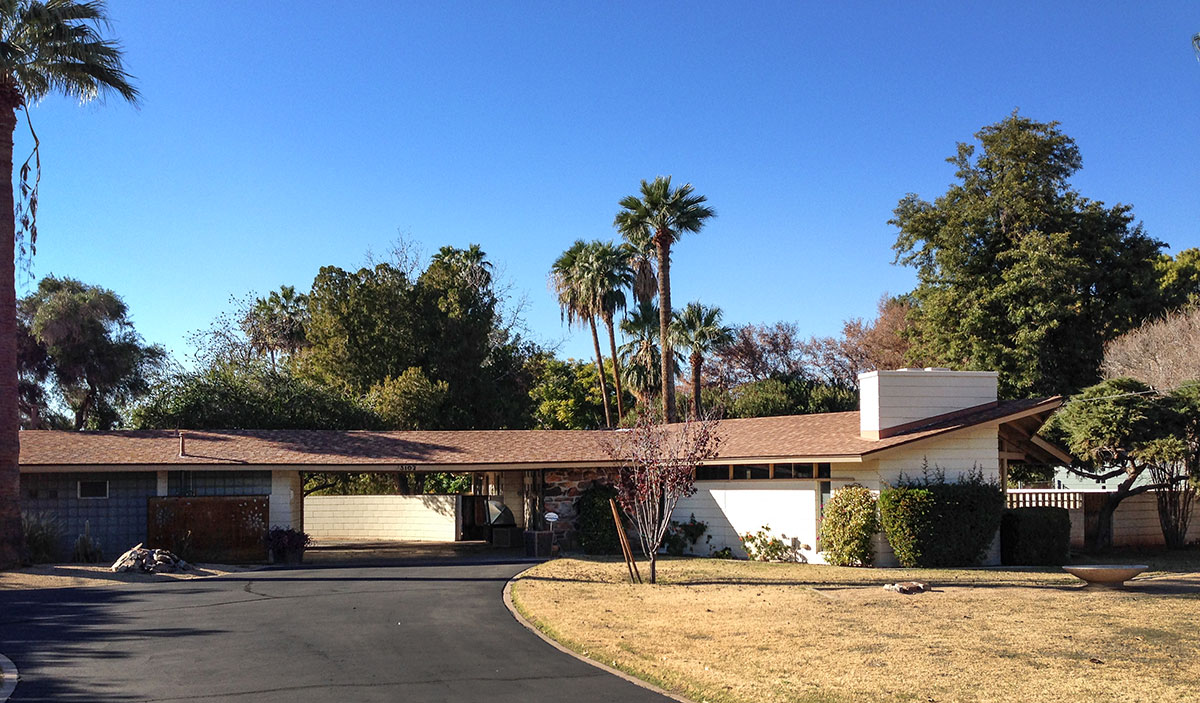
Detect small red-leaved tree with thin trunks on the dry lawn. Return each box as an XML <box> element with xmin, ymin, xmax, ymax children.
<box><xmin>606</xmin><ymin>414</ymin><xmax>721</xmax><ymax>583</ymax></box>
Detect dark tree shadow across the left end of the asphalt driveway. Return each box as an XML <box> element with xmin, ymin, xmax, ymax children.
<box><xmin>0</xmin><ymin>588</ymin><xmax>221</xmax><ymax>702</ymax></box>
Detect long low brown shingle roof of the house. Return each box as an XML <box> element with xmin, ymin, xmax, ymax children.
<box><xmin>20</xmin><ymin>398</ymin><xmax>1061</xmax><ymax>468</ymax></box>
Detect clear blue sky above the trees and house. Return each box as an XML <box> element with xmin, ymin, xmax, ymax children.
<box><xmin>17</xmin><ymin>1</ymin><xmax>1200</xmax><ymax>357</ymax></box>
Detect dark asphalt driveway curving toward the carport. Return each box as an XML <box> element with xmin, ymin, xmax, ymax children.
<box><xmin>0</xmin><ymin>563</ymin><xmax>667</xmax><ymax>703</ymax></box>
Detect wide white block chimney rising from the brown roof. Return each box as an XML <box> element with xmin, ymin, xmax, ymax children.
<box><xmin>858</xmin><ymin>368</ymin><xmax>998</xmax><ymax>439</ymax></box>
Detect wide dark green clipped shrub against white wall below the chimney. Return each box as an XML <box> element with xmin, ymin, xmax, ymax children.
<box><xmin>880</xmin><ymin>471</ymin><xmax>1004</xmax><ymax>566</ymax></box>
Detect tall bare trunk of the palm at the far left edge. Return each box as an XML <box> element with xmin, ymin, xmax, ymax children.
<box><xmin>0</xmin><ymin>91</ymin><xmax>24</xmax><ymax>569</ymax></box>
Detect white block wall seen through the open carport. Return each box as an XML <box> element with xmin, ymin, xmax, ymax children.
<box><xmin>304</xmin><ymin>495</ymin><xmax>462</xmax><ymax>542</ymax></box>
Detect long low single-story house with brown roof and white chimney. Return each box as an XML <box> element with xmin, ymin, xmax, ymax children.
<box><xmin>20</xmin><ymin>368</ymin><xmax>1069</xmax><ymax>563</ymax></box>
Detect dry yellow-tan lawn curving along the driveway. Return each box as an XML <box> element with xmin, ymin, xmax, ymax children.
<box><xmin>512</xmin><ymin>551</ymin><xmax>1200</xmax><ymax>703</ymax></box>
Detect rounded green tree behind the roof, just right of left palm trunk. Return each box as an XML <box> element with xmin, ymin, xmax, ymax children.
<box><xmin>17</xmin><ymin>276</ymin><xmax>167</xmax><ymax>429</ymax></box>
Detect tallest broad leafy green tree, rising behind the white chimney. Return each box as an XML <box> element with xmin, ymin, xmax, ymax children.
<box><xmin>890</xmin><ymin>113</ymin><xmax>1163</xmax><ymax>396</ymax></box>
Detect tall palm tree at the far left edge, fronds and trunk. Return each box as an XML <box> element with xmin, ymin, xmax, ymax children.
<box><xmin>0</xmin><ymin>0</ymin><xmax>138</xmax><ymax>567</ymax></box>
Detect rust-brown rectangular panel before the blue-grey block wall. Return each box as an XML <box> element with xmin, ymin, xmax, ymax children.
<box><xmin>146</xmin><ymin>495</ymin><xmax>270</xmax><ymax>564</ymax></box>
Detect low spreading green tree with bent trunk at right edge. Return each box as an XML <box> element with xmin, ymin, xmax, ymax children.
<box><xmin>1042</xmin><ymin>378</ymin><xmax>1200</xmax><ymax>551</ymax></box>
